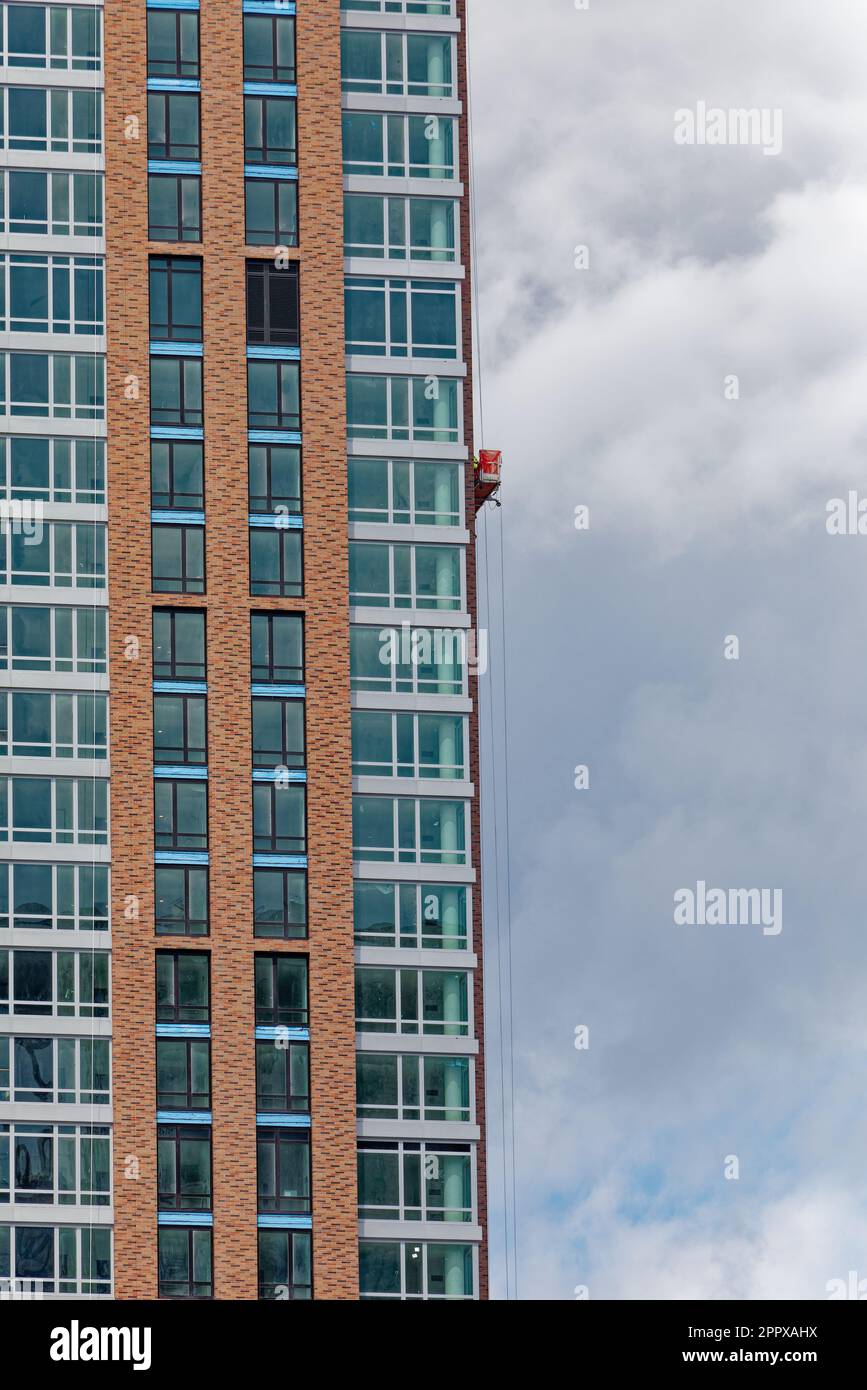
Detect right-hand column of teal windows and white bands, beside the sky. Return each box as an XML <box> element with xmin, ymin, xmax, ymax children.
<box><xmin>340</xmin><ymin>0</ymin><xmax>486</xmax><ymax>1300</ymax></box>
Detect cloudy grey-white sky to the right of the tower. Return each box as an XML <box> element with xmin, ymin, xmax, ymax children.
<box><xmin>470</xmin><ymin>0</ymin><xmax>867</xmax><ymax>1300</ymax></box>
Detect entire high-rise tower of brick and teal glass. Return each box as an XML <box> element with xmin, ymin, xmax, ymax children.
<box><xmin>0</xmin><ymin>0</ymin><xmax>488</xmax><ymax>1300</ymax></box>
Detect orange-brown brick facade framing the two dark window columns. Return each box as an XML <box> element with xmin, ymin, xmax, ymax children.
<box><xmin>106</xmin><ymin>0</ymin><xmax>358</xmax><ymax>1298</ymax></box>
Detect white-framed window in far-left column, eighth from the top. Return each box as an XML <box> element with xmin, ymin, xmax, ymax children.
<box><xmin>0</xmin><ymin>605</ymin><xmax>107</xmax><ymax>674</ymax></box>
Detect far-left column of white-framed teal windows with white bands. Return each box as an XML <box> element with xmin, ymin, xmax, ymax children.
<box><xmin>0</xmin><ymin>0</ymin><xmax>114</xmax><ymax>1298</ymax></box>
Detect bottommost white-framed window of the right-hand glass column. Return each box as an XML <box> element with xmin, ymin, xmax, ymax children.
<box><xmin>358</xmin><ymin>1240</ymin><xmax>475</xmax><ymax>1301</ymax></box>
